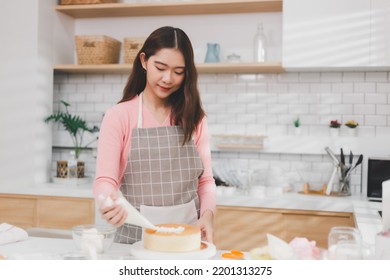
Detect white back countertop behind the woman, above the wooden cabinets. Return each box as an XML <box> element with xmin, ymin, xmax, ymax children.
<box><xmin>0</xmin><ymin>183</ymin><xmax>382</xmax><ymax>245</ymax></box>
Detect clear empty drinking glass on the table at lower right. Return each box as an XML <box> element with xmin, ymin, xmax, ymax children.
<box><xmin>328</xmin><ymin>226</ymin><xmax>364</xmax><ymax>260</ymax></box>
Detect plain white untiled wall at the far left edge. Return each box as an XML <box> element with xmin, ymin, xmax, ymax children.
<box><xmin>0</xmin><ymin>0</ymin><xmax>57</xmax><ymax>190</ymax></box>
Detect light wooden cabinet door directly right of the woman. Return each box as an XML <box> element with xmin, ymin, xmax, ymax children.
<box><xmin>214</xmin><ymin>206</ymin><xmax>283</xmax><ymax>251</ymax></box>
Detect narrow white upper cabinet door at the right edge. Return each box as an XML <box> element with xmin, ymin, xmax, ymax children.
<box><xmin>370</xmin><ymin>0</ymin><xmax>390</xmax><ymax>66</ymax></box>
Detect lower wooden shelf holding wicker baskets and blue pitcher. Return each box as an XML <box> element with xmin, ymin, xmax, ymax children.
<box><xmin>54</xmin><ymin>62</ymin><xmax>284</xmax><ymax>74</ymax></box>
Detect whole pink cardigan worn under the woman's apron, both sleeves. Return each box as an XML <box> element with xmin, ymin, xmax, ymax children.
<box><xmin>93</xmin><ymin>96</ymin><xmax>216</xmax><ymax>215</ymax></box>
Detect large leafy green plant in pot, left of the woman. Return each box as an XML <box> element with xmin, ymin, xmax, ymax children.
<box><xmin>44</xmin><ymin>100</ymin><xmax>99</xmax><ymax>178</ymax></box>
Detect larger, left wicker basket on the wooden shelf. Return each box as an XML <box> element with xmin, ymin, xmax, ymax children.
<box><xmin>75</xmin><ymin>36</ymin><xmax>121</xmax><ymax>64</ymax></box>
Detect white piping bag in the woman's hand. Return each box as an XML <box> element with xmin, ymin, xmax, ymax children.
<box><xmin>98</xmin><ymin>192</ymin><xmax>158</xmax><ymax>230</ymax></box>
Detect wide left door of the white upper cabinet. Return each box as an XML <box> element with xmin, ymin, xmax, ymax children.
<box><xmin>282</xmin><ymin>0</ymin><xmax>370</xmax><ymax>69</ymax></box>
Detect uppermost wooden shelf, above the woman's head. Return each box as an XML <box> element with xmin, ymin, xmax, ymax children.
<box><xmin>56</xmin><ymin>0</ymin><xmax>283</xmax><ymax>18</ymax></box>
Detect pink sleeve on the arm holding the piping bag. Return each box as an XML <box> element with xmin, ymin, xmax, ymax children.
<box><xmin>93</xmin><ymin>105</ymin><xmax>126</xmax><ymax>198</ymax></box>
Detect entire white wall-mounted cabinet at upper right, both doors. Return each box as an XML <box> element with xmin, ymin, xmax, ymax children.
<box><xmin>282</xmin><ymin>0</ymin><xmax>390</xmax><ymax>70</ymax></box>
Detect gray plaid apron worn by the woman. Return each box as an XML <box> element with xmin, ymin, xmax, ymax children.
<box><xmin>115</xmin><ymin>93</ymin><xmax>203</xmax><ymax>244</ymax></box>
